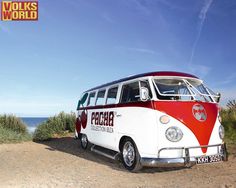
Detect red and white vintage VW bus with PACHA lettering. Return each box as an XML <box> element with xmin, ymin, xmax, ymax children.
<box><xmin>75</xmin><ymin>72</ymin><xmax>227</xmax><ymax>171</ymax></box>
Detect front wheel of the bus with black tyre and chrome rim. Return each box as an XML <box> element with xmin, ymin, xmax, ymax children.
<box><xmin>121</xmin><ymin>138</ymin><xmax>142</xmax><ymax>172</ymax></box>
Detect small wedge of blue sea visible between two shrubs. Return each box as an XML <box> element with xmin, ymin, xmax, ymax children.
<box><xmin>21</xmin><ymin>117</ymin><xmax>48</xmax><ymax>133</ymax></box>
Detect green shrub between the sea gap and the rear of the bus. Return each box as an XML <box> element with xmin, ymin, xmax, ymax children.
<box><xmin>33</xmin><ymin>112</ymin><xmax>76</xmax><ymax>141</ymax></box>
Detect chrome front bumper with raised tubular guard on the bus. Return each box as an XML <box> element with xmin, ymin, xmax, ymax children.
<box><xmin>140</xmin><ymin>143</ymin><xmax>228</xmax><ymax>167</ymax></box>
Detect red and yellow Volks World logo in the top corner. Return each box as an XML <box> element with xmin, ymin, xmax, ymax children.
<box><xmin>1</xmin><ymin>1</ymin><xmax>38</xmax><ymax>21</ymax></box>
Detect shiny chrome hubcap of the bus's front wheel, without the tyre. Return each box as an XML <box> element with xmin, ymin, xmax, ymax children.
<box><xmin>123</xmin><ymin>141</ymin><xmax>135</xmax><ymax>166</ymax></box>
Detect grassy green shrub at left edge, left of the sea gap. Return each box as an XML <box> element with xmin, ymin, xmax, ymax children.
<box><xmin>0</xmin><ymin>115</ymin><xmax>32</xmax><ymax>144</ymax></box>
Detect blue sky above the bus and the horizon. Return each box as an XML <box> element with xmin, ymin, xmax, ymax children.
<box><xmin>0</xmin><ymin>0</ymin><xmax>236</xmax><ymax>117</ymax></box>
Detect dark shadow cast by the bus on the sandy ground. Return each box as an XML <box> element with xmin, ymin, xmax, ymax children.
<box><xmin>36</xmin><ymin>137</ymin><xmax>186</xmax><ymax>173</ymax></box>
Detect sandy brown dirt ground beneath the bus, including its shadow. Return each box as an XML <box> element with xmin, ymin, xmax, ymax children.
<box><xmin>0</xmin><ymin>137</ymin><xmax>236</xmax><ymax>188</ymax></box>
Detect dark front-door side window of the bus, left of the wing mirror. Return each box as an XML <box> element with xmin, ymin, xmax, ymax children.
<box><xmin>120</xmin><ymin>82</ymin><xmax>140</xmax><ymax>103</ymax></box>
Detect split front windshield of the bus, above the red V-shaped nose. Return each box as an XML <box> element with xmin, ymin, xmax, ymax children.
<box><xmin>154</xmin><ymin>78</ymin><xmax>214</xmax><ymax>102</ymax></box>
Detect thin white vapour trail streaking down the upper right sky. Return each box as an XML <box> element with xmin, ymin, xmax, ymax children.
<box><xmin>189</xmin><ymin>0</ymin><xmax>213</xmax><ymax>65</ymax></box>
